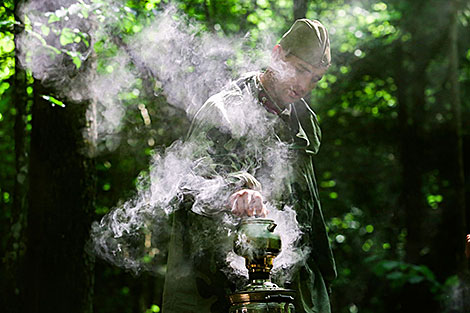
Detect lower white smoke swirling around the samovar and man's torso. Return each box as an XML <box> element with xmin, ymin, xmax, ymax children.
<box><xmin>88</xmin><ymin>78</ymin><xmax>308</xmax><ymax>280</ymax></box>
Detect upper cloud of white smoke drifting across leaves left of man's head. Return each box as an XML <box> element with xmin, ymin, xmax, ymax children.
<box><xmin>17</xmin><ymin>0</ymin><xmax>274</xmax><ymax>153</ymax></box>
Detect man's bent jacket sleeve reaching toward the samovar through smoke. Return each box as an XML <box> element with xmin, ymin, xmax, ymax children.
<box><xmin>186</xmin><ymin>95</ymin><xmax>261</xmax><ymax>216</ymax></box>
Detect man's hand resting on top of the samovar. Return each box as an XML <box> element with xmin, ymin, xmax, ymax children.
<box><xmin>229</xmin><ymin>189</ymin><xmax>268</xmax><ymax>217</ymax></box>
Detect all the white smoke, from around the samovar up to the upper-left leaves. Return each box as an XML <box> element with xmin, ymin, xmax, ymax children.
<box><xmin>17</xmin><ymin>0</ymin><xmax>308</xmax><ymax>282</ymax></box>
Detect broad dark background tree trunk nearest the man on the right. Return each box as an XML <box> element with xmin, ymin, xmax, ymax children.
<box><xmin>396</xmin><ymin>1</ymin><xmax>441</xmax><ymax>264</ymax></box>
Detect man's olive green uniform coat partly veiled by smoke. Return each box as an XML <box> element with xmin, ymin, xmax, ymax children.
<box><xmin>163</xmin><ymin>73</ymin><xmax>336</xmax><ymax>313</ymax></box>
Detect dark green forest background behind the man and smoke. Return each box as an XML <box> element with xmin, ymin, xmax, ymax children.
<box><xmin>0</xmin><ymin>0</ymin><xmax>470</xmax><ymax>313</ymax></box>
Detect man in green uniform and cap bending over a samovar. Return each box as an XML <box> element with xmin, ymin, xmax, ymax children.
<box><xmin>163</xmin><ymin>19</ymin><xmax>336</xmax><ymax>313</ymax></box>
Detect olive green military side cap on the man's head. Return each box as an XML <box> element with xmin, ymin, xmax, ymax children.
<box><xmin>279</xmin><ymin>18</ymin><xmax>331</xmax><ymax>67</ymax></box>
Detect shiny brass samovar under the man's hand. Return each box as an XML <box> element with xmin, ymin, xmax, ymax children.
<box><xmin>229</xmin><ymin>218</ymin><xmax>295</xmax><ymax>313</ymax></box>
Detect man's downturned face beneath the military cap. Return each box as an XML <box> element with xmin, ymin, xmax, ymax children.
<box><xmin>271</xmin><ymin>47</ymin><xmax>326</xmax><ymax>105</ymax></box>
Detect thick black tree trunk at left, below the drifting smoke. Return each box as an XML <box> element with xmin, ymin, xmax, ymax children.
<box><xmin>24</xmin><ymin>83</ymin><xmax>95</xmax><ymax>313</ymax></box>
